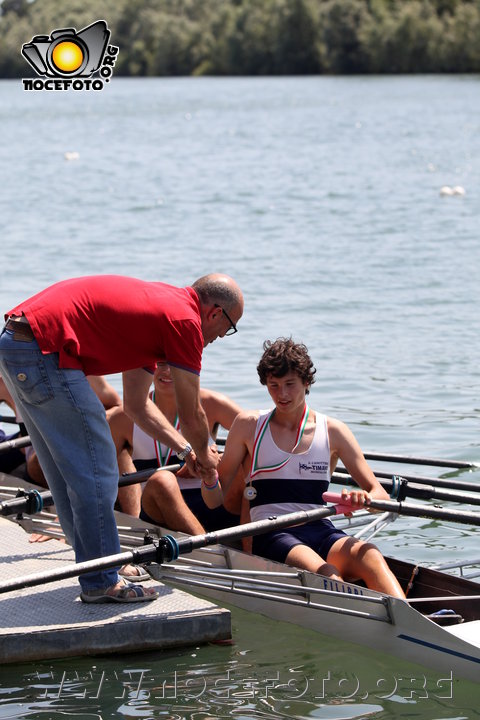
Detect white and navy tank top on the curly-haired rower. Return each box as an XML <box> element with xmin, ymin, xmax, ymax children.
<box><xmin>245</xmin><ymin>411</ymin><xmax>330</xmax><ymax>521</ymax></box>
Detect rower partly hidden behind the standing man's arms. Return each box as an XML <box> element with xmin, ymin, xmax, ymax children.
<box><xmin>109</xmin><ymin>362</ymin><xmax>241</xmax><ymax>535</ymax></box>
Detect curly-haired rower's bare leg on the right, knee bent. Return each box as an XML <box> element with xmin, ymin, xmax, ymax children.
<box><xmin>327</xmin><ymin>537</ymin><xmax>405</xmax><ymax>600</ymax></box>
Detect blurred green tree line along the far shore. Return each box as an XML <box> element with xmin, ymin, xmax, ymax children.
<box><xmin>0</xmin><ymin>0</ymin><xmax>480</xmax><ymax>78</ymax></box>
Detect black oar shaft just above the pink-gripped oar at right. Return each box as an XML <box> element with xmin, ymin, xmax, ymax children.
<box><xmin>332</xmin><ymin>468</ymin><xmax>480</xmax><ymax>505</ymax></box>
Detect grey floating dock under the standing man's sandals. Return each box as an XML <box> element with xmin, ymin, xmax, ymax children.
<box><xmin>0</xmin><ymin>518</ymin><xmax>231</xmax><ymax>663</ymax></box>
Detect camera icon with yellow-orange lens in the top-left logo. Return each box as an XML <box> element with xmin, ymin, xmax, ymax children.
<box><xmin>22</xmin><ymin>20</ymin><xmax>110</xmax><ymax>78</ymax></box>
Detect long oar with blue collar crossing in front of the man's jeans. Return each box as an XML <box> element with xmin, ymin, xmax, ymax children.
<box><xmin>0</xmin><ymin>507</ymin><xmax>336</xmax><ymax>593</ymax></box>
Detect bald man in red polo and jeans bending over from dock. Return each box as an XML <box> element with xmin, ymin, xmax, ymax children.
<box><xmin>0</xmin><ymin>274</ymin><xmax>243</xmax><ymax>602</ymax></box>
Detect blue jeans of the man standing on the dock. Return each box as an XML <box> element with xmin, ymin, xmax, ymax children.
<box><xmin>0</xmin><ymin>330</ymin><xmax>120</xmax><ymax>590</ymax></box>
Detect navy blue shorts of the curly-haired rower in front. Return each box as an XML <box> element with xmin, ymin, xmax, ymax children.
<box><xmin>252</xmin><ymin>520</ymin><xmax>347</xmax><ymax>562</ymax></box>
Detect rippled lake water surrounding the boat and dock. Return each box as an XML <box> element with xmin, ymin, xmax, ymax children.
<box><xmin>0</xmin><ymin>76</ymin><xmax>480</xmax><ymax>720</ymax></box>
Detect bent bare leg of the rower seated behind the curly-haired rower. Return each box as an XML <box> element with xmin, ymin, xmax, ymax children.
<box><xmin>142</xmin><ymin>471</ymin><xmax>205</xmax><ymax>535</ymax></box>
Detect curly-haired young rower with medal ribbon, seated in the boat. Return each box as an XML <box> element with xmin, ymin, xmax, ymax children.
<box><xmin>218</xmin><ymin>338</ymin><xmax>405</xmax><ymax>598</ymax></box>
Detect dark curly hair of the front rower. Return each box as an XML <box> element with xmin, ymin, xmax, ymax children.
<box><xmin>257</xmin><ymin>338</ymin><xmax>317</xmax><ymax>393</ymax></box>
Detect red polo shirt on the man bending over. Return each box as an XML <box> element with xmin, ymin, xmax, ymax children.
<box><xmin>7</xmin><ymin>275</ymin><xmax>203</xmax><ymax>375</ymax></box>
